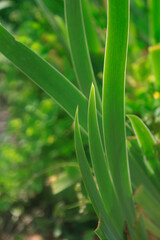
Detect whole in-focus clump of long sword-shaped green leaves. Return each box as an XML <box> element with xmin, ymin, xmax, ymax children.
<box><xmin>0</xmin><ymin>0</ymin><xmax>160</xmax><ymax>240</ymax></box>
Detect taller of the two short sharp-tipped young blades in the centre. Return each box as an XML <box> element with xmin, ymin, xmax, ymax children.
<box><xmin>88</xmin><ymin>85</ymin><xmax>124</xmax><ymax>232</ymax></box>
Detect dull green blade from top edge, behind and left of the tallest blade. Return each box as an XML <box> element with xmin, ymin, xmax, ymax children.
<box><xmin>64</xmin><ymin>0</ymin><xmax>101</xmax><ymax>110</ymax></box>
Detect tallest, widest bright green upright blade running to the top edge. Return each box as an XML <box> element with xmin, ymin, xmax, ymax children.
<box><xmin>103</xmin><ymin>0</ymin><xmax>146</xmax><ymax>239</ymax></box>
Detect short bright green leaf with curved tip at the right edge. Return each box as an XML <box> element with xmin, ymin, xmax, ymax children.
<box><xmin>127</xmin><ymin>115</ymin><xmax>160</xmax><ymax>190</ymax></box>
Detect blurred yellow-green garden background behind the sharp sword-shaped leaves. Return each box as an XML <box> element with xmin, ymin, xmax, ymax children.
<box><xmin>0</xmin><ymin>0</ymin><xmax>160</xmax><ymax>240</ymax></box>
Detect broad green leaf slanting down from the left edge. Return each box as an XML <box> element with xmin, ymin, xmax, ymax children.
<box><xmin>0</xmin><ymin>25</ymin><xmax>88</xmax><ymax>131</ymax></box>
